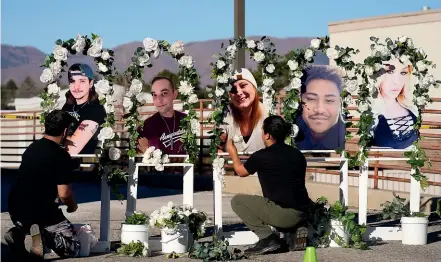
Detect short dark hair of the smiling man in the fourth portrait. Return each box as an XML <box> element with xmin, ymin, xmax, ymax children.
<box><xmin>300</xmin><ymin>65</ymin><xmax>343</xmax><ymax>94</ymax></box>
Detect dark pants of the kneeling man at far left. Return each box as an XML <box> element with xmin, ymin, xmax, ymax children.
<box><xmin>12</xmin><ymin>216</ymin><xmax>81</xmax><ymax>258</ymax></box>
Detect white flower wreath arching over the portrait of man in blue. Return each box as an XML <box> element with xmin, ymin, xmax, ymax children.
<box><xmin>282</xmin><ymin>37</ymin><xmax>359</xmax><ymax>146</ymax></box>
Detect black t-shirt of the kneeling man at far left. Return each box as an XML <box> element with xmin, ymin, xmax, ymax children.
<box><xmin>8</xmin><ymin>138</ymin><xmax>79</xmax><ymax>224</ymax></box>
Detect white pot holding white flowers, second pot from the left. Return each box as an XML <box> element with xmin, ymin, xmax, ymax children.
<box><xmin>161</xmin><ymin>224</ymin><xmax>193</xmax><ymax>254</ymax></box>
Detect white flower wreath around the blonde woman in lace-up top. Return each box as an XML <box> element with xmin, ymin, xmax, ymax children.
<box><xmin>354</xmin><ymin>36</ymin><xmax>441</xmax><ymax>188</ymax></box>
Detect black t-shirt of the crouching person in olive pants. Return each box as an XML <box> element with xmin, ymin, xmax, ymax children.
<box><xmin>244</xmin><ymin>143</ymin><xmax>310</xmax><ymax>211</ymax></box>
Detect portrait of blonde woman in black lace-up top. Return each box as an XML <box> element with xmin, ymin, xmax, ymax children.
<box><xmin>371</xmin><ymin>59</ymin><xmax>418</xmax><ymax>149</ymax></box>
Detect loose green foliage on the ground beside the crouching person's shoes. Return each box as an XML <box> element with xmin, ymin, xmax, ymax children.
<box><xmin>189</xmin><ymin>236</ymin><xmax>246</xmax><ymax>261</ymax></box>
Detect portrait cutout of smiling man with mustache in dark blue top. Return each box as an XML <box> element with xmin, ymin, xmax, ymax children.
<box><xmin>296</xmin><ymin>65</ymin><xmax>346</xmax><ymax>150</ymax></box>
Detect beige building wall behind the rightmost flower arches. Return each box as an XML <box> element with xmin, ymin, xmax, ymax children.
<box><xmin>329</xmin><ymin>9</ymin><xmax>441</xmax><ymax>100</ymax></box>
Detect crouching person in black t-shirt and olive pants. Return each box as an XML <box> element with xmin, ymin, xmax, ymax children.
<box><xmin>227</xmin><ymin>116</ymin><xmax>311</xmax><ymax>255</ymax></box>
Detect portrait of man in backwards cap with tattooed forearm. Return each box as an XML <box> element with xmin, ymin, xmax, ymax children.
<box><xmin>62</xmin><ymin>64</ymin><xmax>106</xmax><ymax>154</ymax></box>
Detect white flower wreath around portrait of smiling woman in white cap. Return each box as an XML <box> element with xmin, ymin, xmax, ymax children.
<box><xmin>207</xmin><ymin>36</ymin><xmax>277</xmax><ymax>186</ymax></box>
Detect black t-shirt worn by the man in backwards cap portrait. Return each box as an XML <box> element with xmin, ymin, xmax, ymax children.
<box><xmin>62</xmin><ymin>100</ymin><xmax>106</xmax><ymax>154</ymax></box>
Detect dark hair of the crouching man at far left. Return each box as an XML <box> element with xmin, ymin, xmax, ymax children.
<box><xmin>44</xmin><ymin>110</ymin><xmax>76</xmax><ymax>136</ymax></box>
